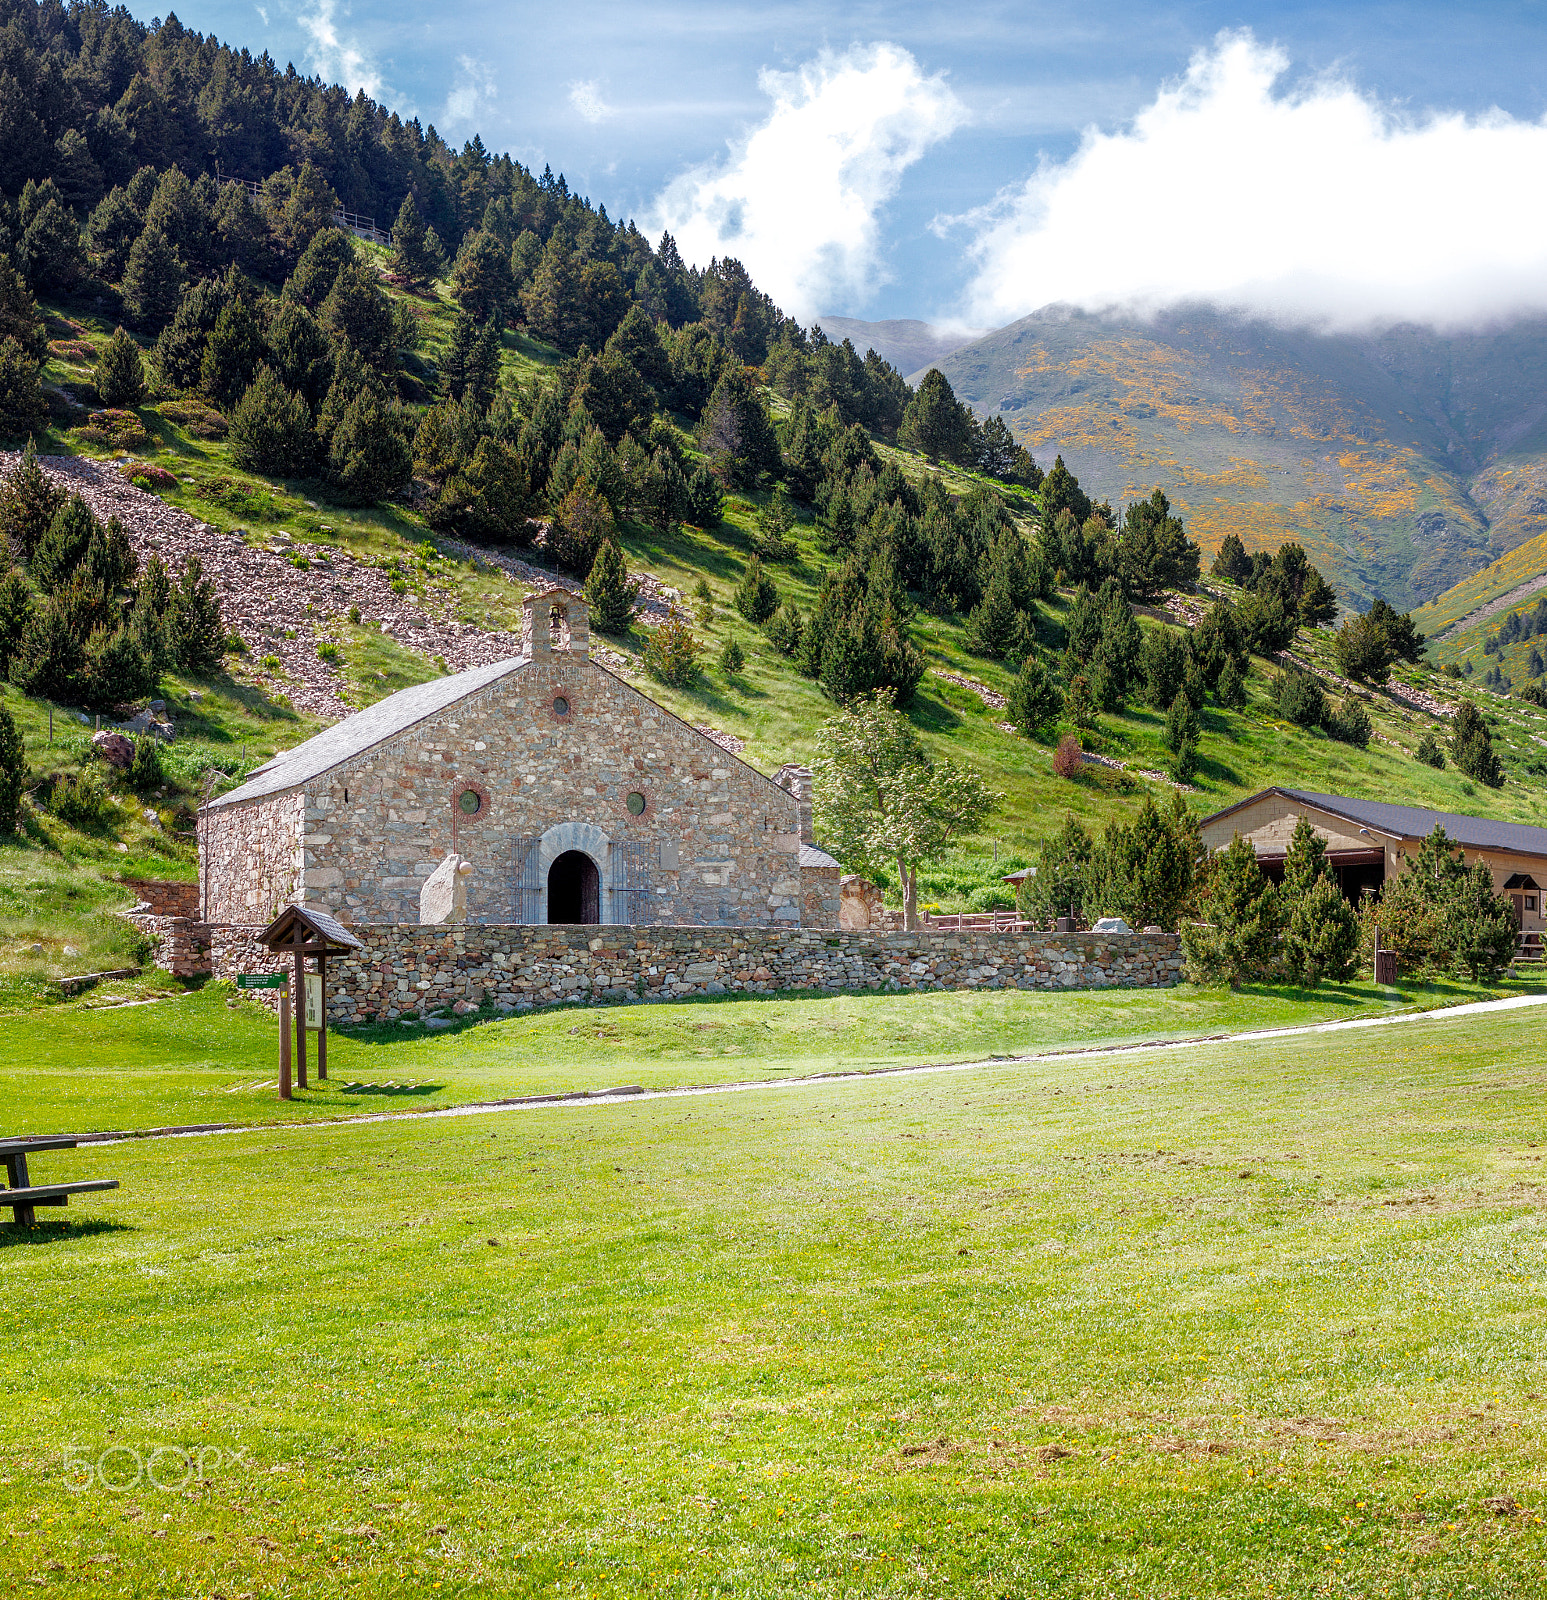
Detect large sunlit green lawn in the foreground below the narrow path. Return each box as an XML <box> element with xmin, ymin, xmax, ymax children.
<box><xmin>0</xmin><ymin>1002</ymin><xmax>1547</xmax><ymax>1600</ymax></box>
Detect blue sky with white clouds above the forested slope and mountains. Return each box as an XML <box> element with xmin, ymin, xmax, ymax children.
<box><xmin>134</xmin><ymin>0</ymin><xmax>1547</xmax><ymax>325</ymax></box>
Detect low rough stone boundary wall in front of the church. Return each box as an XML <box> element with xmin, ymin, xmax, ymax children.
<box><xmin>210</xmin><ymin>923</ymin><xmax>1182</xmax><ymax>1024</ymax></box>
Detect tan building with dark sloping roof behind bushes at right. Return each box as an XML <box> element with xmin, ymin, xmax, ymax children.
<box><xmin>1201</xmin><ymin>789</ymin><xmax>1547</xmax><ymax>955</ymax></box>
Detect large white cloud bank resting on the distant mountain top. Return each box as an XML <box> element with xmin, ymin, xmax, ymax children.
<box><xmin>945</xmin><ymin>32</ymin><xmax>1547</xmax><ymax>328</ymax></box>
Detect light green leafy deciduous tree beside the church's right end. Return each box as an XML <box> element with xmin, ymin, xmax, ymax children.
<box><xmin>813</xmin><ymin>690</ymin><xmax>1001</xmax><ymax>928</ymax></box>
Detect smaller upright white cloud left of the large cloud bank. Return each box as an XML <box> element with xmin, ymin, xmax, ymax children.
<box><xmin>651</xmin><ymin>43</ymin><xmax>966</xmax><ymax>317</ymax></box>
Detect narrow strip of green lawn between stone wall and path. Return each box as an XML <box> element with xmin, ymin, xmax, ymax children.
<box><xmin>0</xmin><ymin>981</ymin><xmax>1525</xmax><ymax>1133</ymax></box>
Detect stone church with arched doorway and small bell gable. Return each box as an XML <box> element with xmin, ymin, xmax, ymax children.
<box><xmin>198</xmin><ymin>590</ymin><xmax>838</xmax><ymax>928</ymax></box>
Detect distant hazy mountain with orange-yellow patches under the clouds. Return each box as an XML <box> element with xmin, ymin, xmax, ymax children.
<box><xmin>912</xmin><ymin>306</ymin><xmax>1547</xmax><ymax>608</ymax></box>
